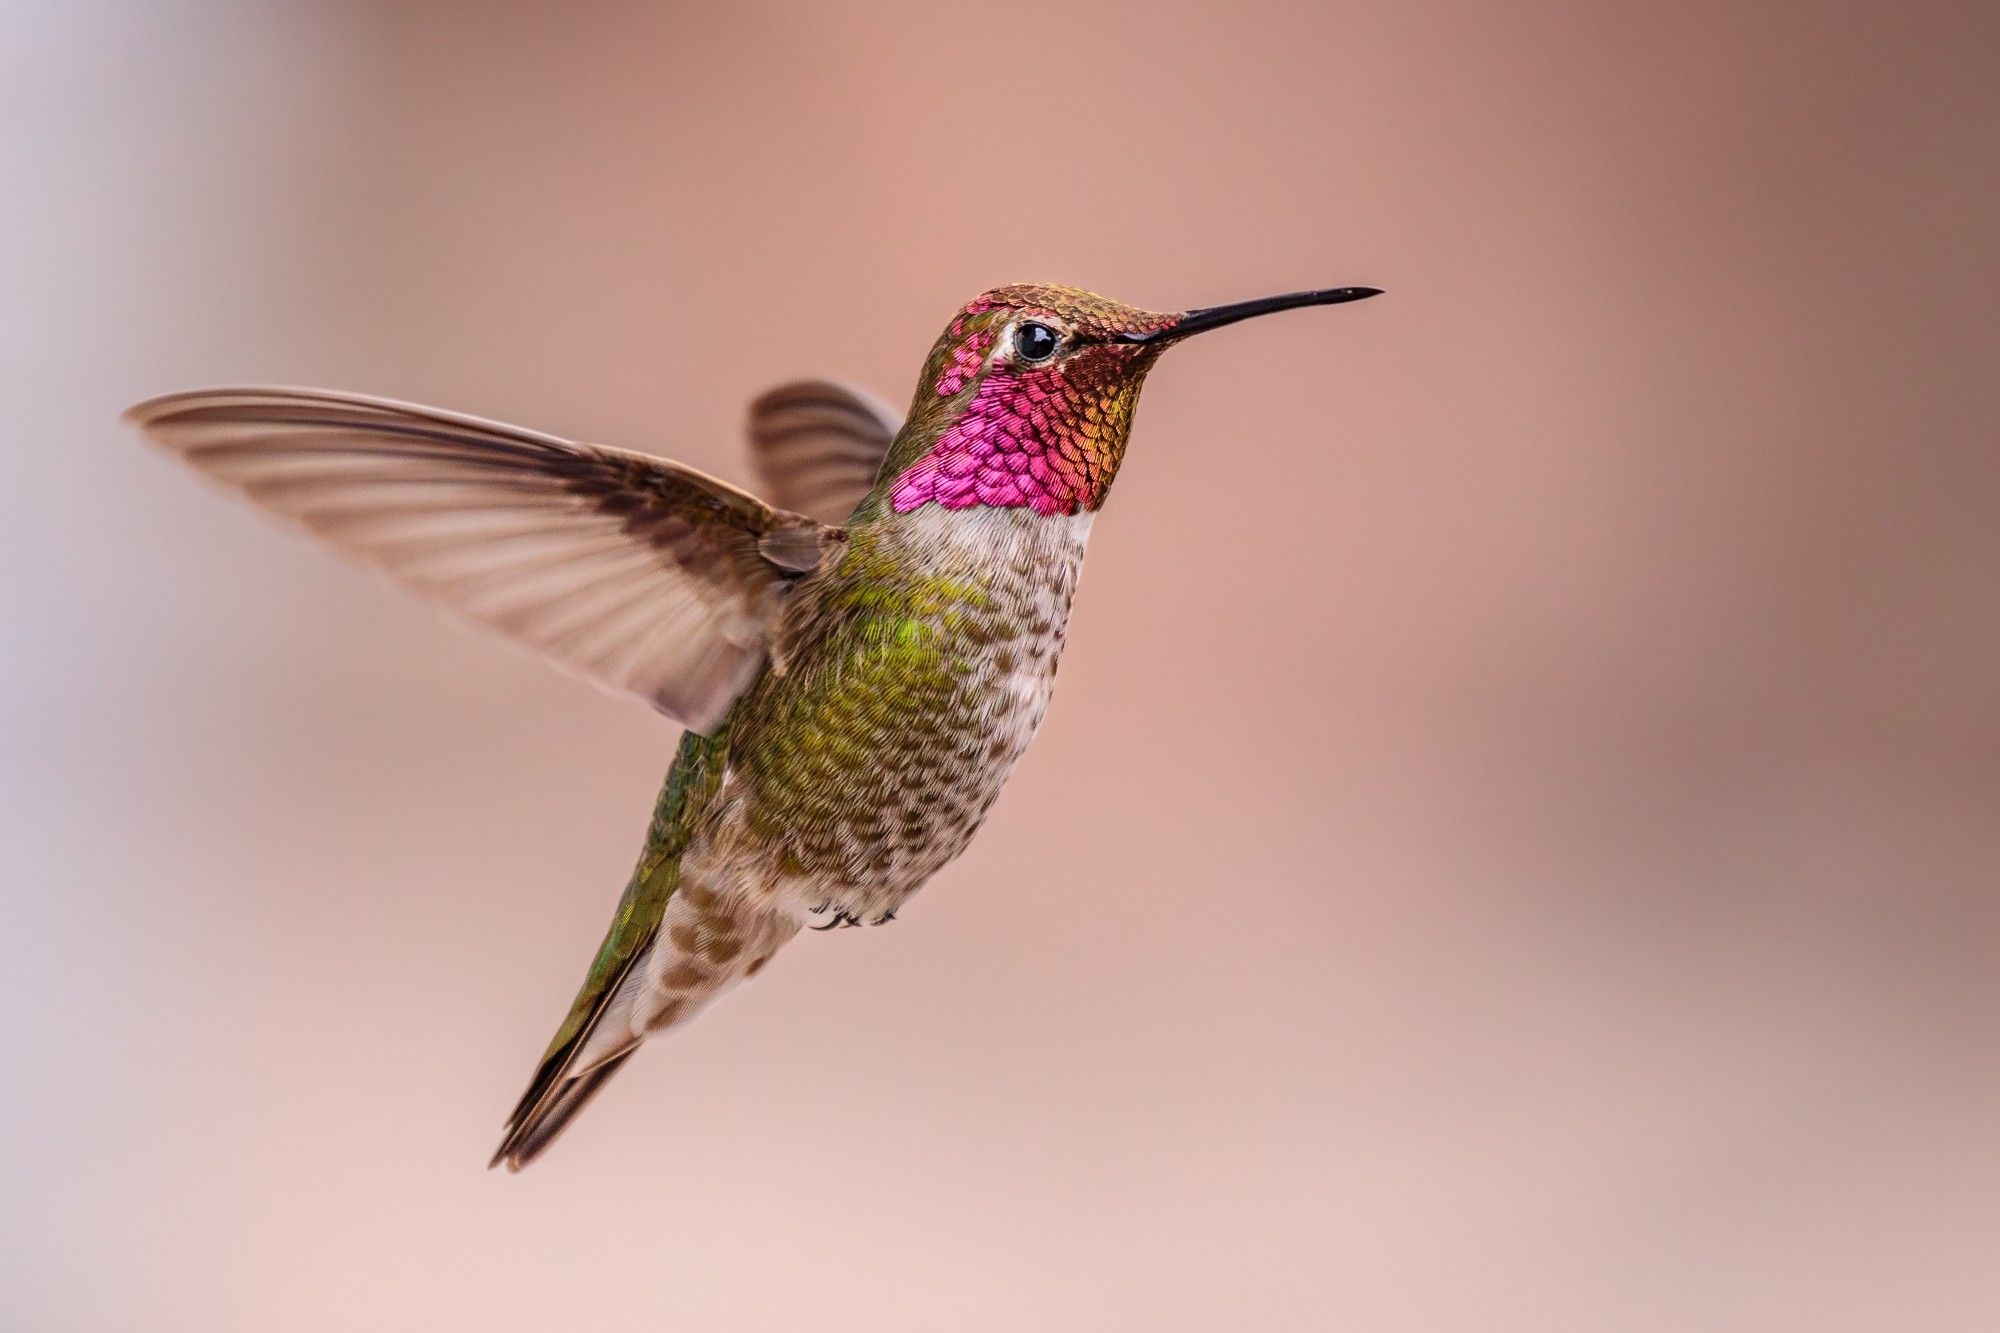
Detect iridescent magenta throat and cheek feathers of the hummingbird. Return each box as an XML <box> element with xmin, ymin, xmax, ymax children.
<box><xmin>890</xmin><ymin>336</ymin><xmax>1136</xmax><ymax>516</ymax></box>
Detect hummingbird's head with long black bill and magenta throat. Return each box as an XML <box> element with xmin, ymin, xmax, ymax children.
<box><xmin>882</xmin><ymin>284</ymin><xmax>1378</xmax><ymax>514</ymax></box>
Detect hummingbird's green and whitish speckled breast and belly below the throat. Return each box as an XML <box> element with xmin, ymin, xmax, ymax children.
<box><xmin>688</xmin><ymin>506</ymin><xmax>1088</xmax><ymax>921</ymax></box>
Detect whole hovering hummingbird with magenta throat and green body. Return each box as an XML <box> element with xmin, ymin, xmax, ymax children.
<box><xmin>126</xmin><ymin>284</ymin><xmax>1380</xmax><ymax>1171</ymax></box>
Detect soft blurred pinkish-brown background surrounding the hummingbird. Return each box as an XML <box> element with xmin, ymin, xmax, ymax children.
<box><xmin>0</xmin><ymin>0</ymin><xmax>2000</xmax><ymax>1333</ymax></box>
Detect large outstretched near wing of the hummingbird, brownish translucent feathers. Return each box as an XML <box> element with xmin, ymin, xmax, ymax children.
<box><xmin>126</xmin><ymin>388</ymin><xmax>842</xmax><ymax>733</ymax></box>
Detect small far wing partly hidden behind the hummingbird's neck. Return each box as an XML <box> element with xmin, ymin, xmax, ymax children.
<box><xmin>750</xmin><ymin>380</ymin><xmax>902</xmax><ymax>522</ymax></box>
